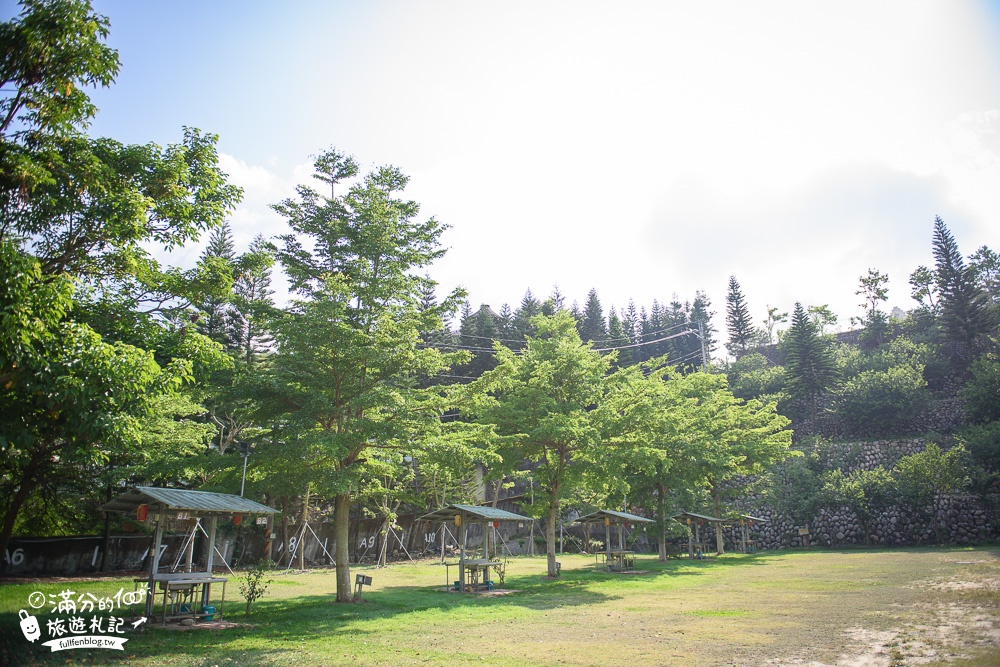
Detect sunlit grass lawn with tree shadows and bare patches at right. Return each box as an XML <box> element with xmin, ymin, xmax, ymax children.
<box><xmin>0</xmin><ymin>547</ymin><xmax>1000</xmax><ymax>667</ymax></box>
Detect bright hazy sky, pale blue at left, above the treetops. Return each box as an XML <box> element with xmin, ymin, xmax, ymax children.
<box><xmin>6</xmin><ymin>0</ymin><xmax>1000</xmax><ymax>350</ymax></box>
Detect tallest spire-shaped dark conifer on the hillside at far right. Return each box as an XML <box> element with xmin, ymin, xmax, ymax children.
<box><xmin>933</xmin><ymin>217</ymin><xmax>990</xmax><ymax>357</ymax></box>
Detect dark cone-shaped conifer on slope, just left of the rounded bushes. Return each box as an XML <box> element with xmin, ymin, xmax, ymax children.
<box><xmin>783</xmin><ymin>303</ymin><xmax>837</xmax><ymax>432</ymax></box>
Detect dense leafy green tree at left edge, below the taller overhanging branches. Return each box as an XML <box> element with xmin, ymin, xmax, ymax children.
<box><xmin>0</xmin><ymin>242</ymin><xmax>178</xmax><ymax>560</ymax></box>
